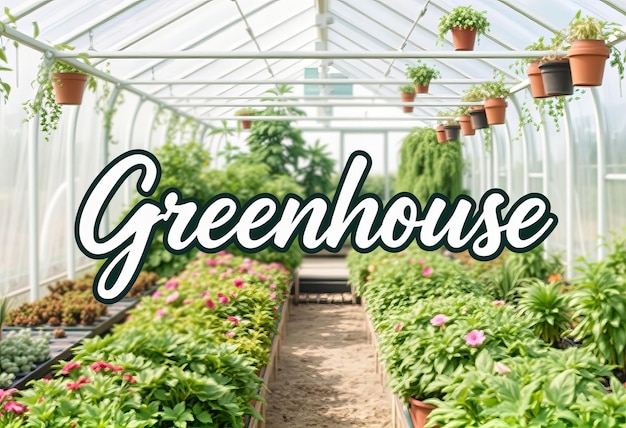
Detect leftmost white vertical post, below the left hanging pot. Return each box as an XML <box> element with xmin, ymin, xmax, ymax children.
<box><xmin>27</xmin><ymin>114</ymin><xmax>39</xmax><ymax>301</ymax></box>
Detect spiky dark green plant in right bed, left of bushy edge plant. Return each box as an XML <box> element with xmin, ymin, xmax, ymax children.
<box><xmin>517</xmin><ymin>279</ymin><xmax>571</xmax><ymax>346</ymax></box>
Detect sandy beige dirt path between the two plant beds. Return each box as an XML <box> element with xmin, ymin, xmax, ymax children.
<box><xmin>266</xmin><ymin>304</ymin><xmax>391</xmax><ymax>428</ymax></box>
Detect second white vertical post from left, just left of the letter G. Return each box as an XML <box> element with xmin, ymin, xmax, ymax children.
<box><xmin>65</xmin><ymin>107</ymin><xmax>80</xmax><ymax>279</ymax></box>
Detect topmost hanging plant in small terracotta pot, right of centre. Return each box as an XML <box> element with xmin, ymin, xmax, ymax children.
<box><xmin>439</xmin><ymin>6</ymin><xmax>489</xmax><ymax>51</ymax></box>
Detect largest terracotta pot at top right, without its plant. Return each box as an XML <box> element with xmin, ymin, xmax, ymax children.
<box><xmin>567</xmin><ymin>40</ymin><xmax>611</xmax><ymax>86</ymax></box>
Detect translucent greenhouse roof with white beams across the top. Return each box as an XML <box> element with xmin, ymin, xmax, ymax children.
<box><xmin>4</xmin><ymin>0</ymin><xmax>626</xmax><ymax>126</ymax></box>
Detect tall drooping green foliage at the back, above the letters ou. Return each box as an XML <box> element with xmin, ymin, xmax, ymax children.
<box><xmin>395</xmin><ymin>128</ymin><xmax>463</xmax><ymax>206</ymax></box>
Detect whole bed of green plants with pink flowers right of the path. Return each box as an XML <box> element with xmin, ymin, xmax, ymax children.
<box><xmin>348</xmin><ymin>236</ymin><xmax>626</xmax><ymax>428</ymax></box>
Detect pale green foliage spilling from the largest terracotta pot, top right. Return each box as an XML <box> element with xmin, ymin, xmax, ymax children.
<box><xmin>566</xmin><ymin>10</ymin><xmax>626</xmax><ymax>79</ymax></box>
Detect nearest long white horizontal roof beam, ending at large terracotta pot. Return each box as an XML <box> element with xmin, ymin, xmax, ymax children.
<box><xmin>58</xmin><ymin>50</ymin><xmax>567</xmax><ymax>59</ymax></box>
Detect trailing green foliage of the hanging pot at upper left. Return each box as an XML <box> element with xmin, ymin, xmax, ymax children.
<box><xmin>24</xmin><ymin>44</ymin><xmax>97</xmax><ymax>141</ymax></box>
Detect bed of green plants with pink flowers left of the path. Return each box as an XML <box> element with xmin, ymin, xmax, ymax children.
<box><xmin>0</xmin><ymin>252</ymin><xmax>291</xmax><ymax>427</ymax></box>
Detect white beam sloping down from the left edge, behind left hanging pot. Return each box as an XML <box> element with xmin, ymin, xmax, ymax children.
<box><xmin>0</xmin><ymin>27</ymin><xmax>210</xmax><ymax>127</ymax></box>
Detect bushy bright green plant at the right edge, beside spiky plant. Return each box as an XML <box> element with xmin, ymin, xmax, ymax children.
<box><xmin>570</xmin><ymin>263</ymin><xmax>626</xmax><ymax>369</ymax></box>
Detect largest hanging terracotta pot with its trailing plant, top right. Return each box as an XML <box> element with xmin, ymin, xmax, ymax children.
<box><xmin>567</xmin><ymin>10</ymin><xmax>624</xmax><ymax>86</ymax></box>
